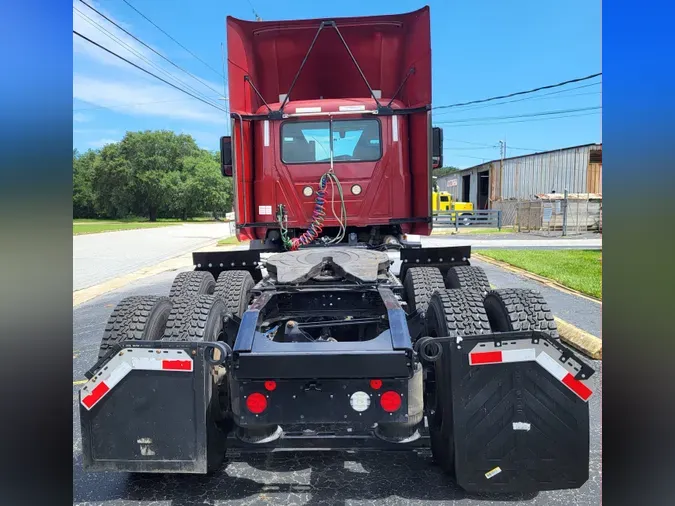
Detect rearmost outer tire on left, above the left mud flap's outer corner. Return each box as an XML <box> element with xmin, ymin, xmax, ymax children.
<box><xmin>98</xmin><ymin>295</ymin><xmax>172</xmax><ymax>359</ymax></box>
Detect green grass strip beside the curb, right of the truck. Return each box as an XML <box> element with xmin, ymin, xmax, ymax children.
<box><xmin>476</xmin><ymin>249</ymin><xmax>602</xmax><ymax>299</ymax></box>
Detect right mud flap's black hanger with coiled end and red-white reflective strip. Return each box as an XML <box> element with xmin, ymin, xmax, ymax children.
<box><xmin>415</xmin><ymin>331</ymin><xmax>595</xmax><ymax>401</ymax></box>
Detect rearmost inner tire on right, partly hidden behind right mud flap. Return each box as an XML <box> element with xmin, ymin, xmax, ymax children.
<box><xmin>424</xmin><ymin>289</ymin><xmax>491</xmax><ymax>476</ymax></box>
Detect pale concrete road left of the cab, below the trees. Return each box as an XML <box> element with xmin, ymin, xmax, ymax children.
<box><xmin>73</xmin><ymin>223</ymin><xmax>232</xmax><ymax>291</ymax></box>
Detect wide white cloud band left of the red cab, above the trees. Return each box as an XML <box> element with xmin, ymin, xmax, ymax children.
<box><xmin>73</xmin><ymin>74</ymin><xmax>228</xmax><ymax>124</ymax></box>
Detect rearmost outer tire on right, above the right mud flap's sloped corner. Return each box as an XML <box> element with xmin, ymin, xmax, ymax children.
<box><xmin>484</xmin><ymin>288</ymin><xmax>560</xmax><ymax>339</ymax></box>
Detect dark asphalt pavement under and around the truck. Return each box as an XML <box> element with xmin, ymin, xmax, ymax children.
<box><xmin>73</xmin><ymin>261</ymin><xmax>602</xmax><ymax>506</ymax></box>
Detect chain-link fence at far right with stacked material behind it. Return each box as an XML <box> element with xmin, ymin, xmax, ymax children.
<box><xmin>503</xmin><ymin>194</ymin><xmax>602</xmax><ymax>236</ymax></box>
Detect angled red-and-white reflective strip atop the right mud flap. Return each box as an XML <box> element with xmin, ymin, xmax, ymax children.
<box><xmin>469</xmin><ymin>340</ymin><xmax>593</xmax><ymax>401</ymax></box>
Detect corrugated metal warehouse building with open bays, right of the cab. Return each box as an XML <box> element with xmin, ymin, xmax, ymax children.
<box><xmin>436</xmin><ymin>144</ymin><xmax>602</xmax><ymax>209</ymax></box>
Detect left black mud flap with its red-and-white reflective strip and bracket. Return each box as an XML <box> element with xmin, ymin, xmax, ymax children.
<box><xmin>80</xmin><ymin>341</ymin><xmax>224</xmax><ymax>473</ymax></box>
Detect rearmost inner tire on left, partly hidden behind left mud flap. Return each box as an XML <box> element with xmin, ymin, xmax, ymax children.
<box><xmin>163</xmin><ymin>295</ymin><xmax>228</xmax><ymax>473</ymax></box>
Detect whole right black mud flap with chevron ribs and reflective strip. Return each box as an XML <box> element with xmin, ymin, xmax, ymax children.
<box><xmin>441</xmin><ymin>332</ymin><xmax>594</xmax><ymax>492</ymax></box>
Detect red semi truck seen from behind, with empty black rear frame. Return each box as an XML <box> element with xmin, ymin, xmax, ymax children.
<box><xmin>80</xmin><ymin>7</ymin><xmax>594</xmax><ymax>492</ymax></box>
